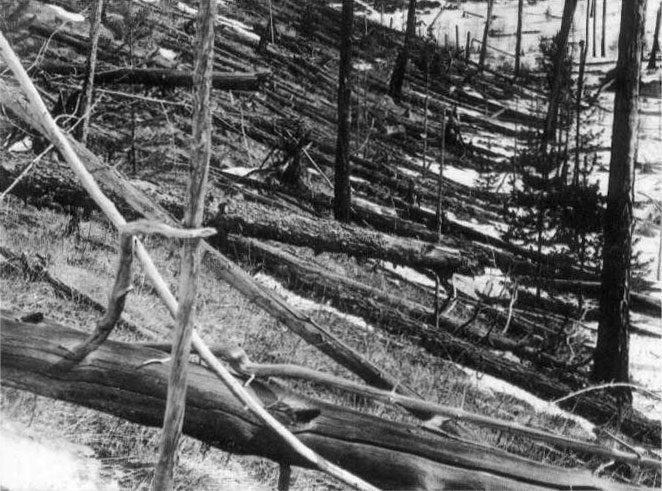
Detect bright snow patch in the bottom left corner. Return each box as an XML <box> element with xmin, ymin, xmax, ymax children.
<box><xmin>0</xmin><ymin>415</ymin><xmax>120</xmax><ymax>491</ymax></box>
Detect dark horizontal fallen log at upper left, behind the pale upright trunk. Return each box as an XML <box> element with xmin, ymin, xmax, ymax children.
<box><xmin>39</xmin><ymin>63</ymin><xmax>270</xmax><ymax>91</ymax></box>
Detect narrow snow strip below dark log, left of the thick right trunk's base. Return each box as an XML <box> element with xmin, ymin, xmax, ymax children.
<box><xmin>456</xmin><ymin>365</ymin><xmax>595</xmax><ymax>439</ymax></box>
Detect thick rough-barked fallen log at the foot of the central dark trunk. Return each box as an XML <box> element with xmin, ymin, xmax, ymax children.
<box><xmin>208</xmin><ymin>201</ymin><xmax>469</xmax><ymax>276</ymax></box>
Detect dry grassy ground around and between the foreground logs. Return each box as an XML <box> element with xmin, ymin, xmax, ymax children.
<box><xmin>0</xmin><ymin>185</ymin><xmax>660</xmax><ymax>490</ymax></box>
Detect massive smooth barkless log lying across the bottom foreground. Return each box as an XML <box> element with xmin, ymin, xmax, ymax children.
<box><xmin>0</xmin><ymin>310</ymin><xmax>652</xmax><ymax>491</ymax></box>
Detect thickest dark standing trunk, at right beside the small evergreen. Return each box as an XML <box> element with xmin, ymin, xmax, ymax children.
<box><xmin>593</xmin><ymin>0</ymin><xmax>646</xmax><ymax>402</ymax></box>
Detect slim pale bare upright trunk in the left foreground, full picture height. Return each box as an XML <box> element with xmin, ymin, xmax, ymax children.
<box><xmin>152</xmin><ymin>0</ymin><xmax>216</xmax><ymax>491</ymax></box>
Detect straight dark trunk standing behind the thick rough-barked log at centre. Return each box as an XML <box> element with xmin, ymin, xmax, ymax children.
<box><xmin>333</xmin><ymin>0</ymin><xmax>354</xmax><ymax>222</ymax></box>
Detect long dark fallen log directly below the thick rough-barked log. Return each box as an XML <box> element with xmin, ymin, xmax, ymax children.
<box><xmin>228</xmin><ymin>237</ymin><xmax>661</xmax><ymax>445</ymax></box>
